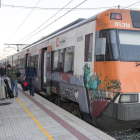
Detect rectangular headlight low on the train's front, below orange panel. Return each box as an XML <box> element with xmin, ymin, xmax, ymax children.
<box><xmin>119</xmin><ymin>94</ymin><xmax>138</xmax><ymax>103</ymax></box>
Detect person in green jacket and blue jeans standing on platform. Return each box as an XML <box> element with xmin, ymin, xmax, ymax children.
<box><xmin>5</xmin><ymin>64</ymin><xmax>19</xmax><ymax>97</ymax></box>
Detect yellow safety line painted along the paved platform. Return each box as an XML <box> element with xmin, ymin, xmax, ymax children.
<box><xmin>16</xmin><ymin>98</ymin><xmax>53</xmax><ymax>140</ymax></box>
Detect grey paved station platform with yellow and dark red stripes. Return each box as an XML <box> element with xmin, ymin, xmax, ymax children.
<box><xmin>0</xmin><ymin>84</ymin><xmax>114</xmax><ymax>140</ymax></box>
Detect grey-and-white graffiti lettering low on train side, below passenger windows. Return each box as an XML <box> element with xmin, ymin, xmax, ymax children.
<box><xmin>60</xmin><ymin>86</ymin><xmax>78</xmax><ymax>102</ymax></box>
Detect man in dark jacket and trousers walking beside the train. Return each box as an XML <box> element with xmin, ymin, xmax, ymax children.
<box><xmin>23</xmin><ymin>61</ymin><xmax>38</xmax><ymax>96</ymax></box>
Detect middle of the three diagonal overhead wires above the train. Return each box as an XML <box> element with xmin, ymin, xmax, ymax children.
<box><xmin>18</xmin><ymin>0</ymin><xmax>73</xmax><ymax>42</ymax></box>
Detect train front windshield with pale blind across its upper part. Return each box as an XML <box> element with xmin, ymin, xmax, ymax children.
<box><xmin>118</xmin><ymin>30</ymin><xmax>140</xmax><ymax>62</ymax></box>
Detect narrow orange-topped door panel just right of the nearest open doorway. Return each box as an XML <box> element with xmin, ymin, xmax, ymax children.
<box><xmin>46</xmin><ymin>46</ymin><xmax>52</xmax><ymax>95</ymax></box>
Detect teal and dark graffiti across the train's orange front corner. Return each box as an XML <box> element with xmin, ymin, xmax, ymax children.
<box><xmin>84</xmin><ymin>64</ymin><xmax>121</xmax><ymax>101</ymax></box>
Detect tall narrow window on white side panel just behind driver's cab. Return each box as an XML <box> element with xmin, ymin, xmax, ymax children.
<box><xmin>85</xmin><ymin>34</ymin><xmax>93</xmax><ymax>62</ymax></box>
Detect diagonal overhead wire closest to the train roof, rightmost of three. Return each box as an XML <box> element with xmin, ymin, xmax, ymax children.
<box><xmin>19</xmin><ymin>0</ymin><xmax>87</xmax><ymax>43</ymax></box>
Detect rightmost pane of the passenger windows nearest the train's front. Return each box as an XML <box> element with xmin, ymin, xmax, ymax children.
<box><xmin>64</xmin><ymin>47</ymin><xmax>74</xmax><ymax>73</ymax></box>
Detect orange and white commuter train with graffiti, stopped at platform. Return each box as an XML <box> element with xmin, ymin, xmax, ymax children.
<box><xmin>0</xmin><ymin>9</ymin><xmax>140</xmax><ymax>132</ymax></box>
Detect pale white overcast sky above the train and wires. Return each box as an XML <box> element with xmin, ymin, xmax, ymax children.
<box><xmin>0</xmin><ymin>0</ymin><xmax>140</xmax><ymax>59</ymax></box>
